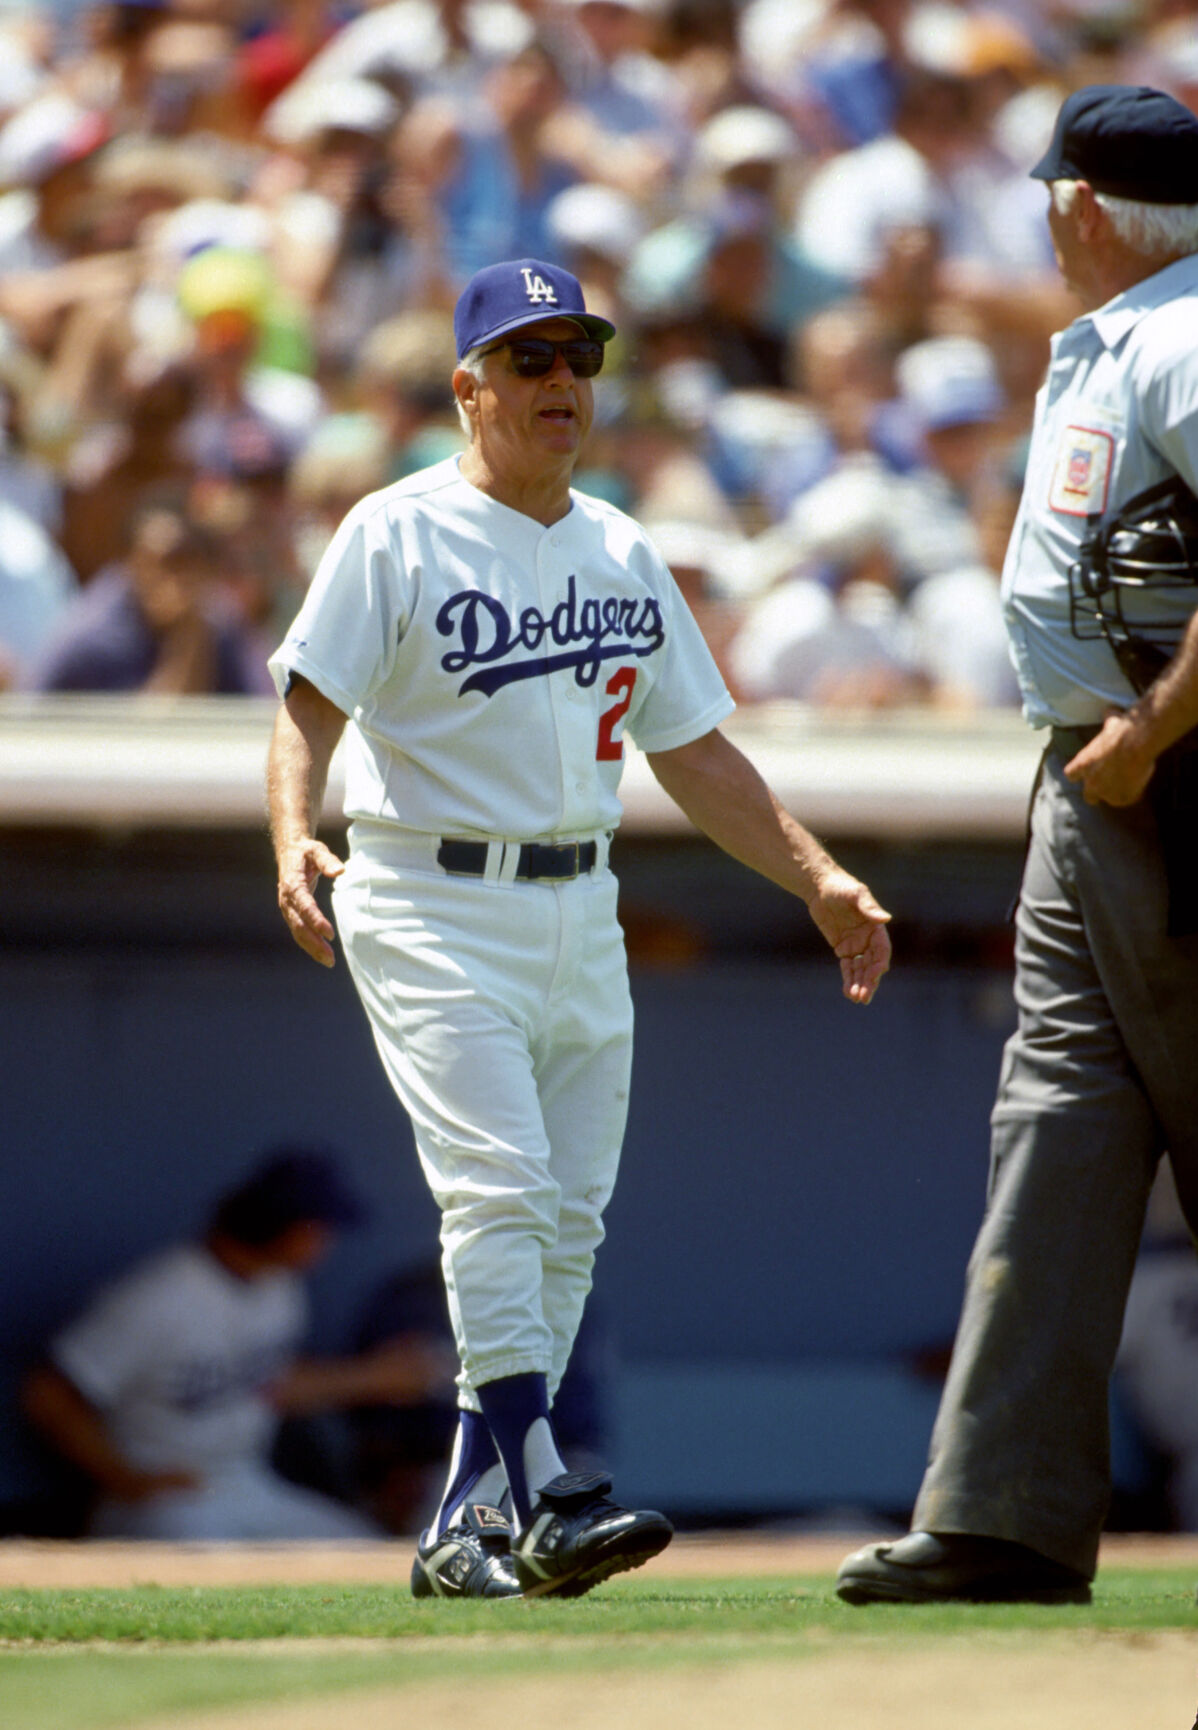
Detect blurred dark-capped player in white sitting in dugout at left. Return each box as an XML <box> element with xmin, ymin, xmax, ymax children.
<box><xmin>23</xmin><ymin>1147</ymin><xmax>454</xmax><ymax>1541</ymax></box>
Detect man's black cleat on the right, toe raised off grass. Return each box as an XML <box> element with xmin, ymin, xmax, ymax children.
<box><xmin>512</xmin><ymin>1472</ymin><xmax>673</xmax><ymax>1599</ymax></box>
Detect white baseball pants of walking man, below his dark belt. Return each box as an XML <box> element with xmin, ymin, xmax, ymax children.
<box><xmin>334</xmin><ymin>825</ymin><xmax>632</xmax><ymax>1408</ymax></box>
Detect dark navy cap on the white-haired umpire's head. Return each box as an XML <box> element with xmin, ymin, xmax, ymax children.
<box><xmin>1032</xmin><ymin>85</ymin><xmax>1198</xmax><ymax>204</ymax></box>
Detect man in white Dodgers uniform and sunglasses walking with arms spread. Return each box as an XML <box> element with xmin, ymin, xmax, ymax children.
<box><xmin>268</xmin><ymin>260</ymin><xmax>890</xmax><ymax>1597</ymax></box>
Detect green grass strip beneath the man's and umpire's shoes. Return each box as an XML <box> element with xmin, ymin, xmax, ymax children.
<box><xmin>0</xmin><ymin>1567</ymin><xmax>1198</xmax><ymax>1730</ymax></box>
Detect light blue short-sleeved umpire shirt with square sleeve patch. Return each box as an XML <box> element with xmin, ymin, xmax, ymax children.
<box><xmin>1002</xmin><ymin>256</ymin><xmax>1198</xmax><ymax>727</ymax></box>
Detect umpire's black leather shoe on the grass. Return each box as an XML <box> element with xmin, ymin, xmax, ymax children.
<box><xmin>836</xmin><ymin>1531</ymin><xmax>1091</xmax><ymax>1604</ymax></box>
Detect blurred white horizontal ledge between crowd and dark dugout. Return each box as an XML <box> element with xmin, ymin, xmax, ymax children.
<box><xmin>0</xmin><ymin>695</ymin><xmax>1039</xmax><ymax>841</ymax></box>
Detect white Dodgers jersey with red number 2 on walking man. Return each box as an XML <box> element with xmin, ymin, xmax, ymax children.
<box><xmin>270</xmin><ymin>458</ymin><xmax>734</xmax><ymax>839</ymax></box>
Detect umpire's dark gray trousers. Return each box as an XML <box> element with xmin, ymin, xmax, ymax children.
<box><xmin>912</xmin><ymin>737</ymin><xmax>1198</xmax><ymax>1574</ymax></box>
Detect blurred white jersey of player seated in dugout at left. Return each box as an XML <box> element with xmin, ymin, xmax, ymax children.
<box><xmin>50</xmin><ymin>1244</ymin><xmax>308</xmax><ymax>1474</ymax></box>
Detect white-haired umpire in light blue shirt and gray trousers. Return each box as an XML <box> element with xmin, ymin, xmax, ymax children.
<box><xmin>838</xmin><ymin>85</ymin><xmax>1198</xmax><ymax>1604</ymax></box>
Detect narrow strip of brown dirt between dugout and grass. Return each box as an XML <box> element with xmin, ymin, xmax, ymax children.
<box><xmin>0</xmin><ymin>1533</ymin><xmax>1198</xmax><ymax>1590</ymax></box>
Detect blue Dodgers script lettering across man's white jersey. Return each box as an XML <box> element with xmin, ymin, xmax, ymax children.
<box><xmin>436</xmin><ymin>576</ymin><xmax>665</xmax><ymax>697</ymax></box>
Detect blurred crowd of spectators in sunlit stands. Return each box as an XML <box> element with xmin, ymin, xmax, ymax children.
<box><xmin>0</xmin><ymin>0</ymin><xmax>1198</xmax><ymax>709</ymax></box>
